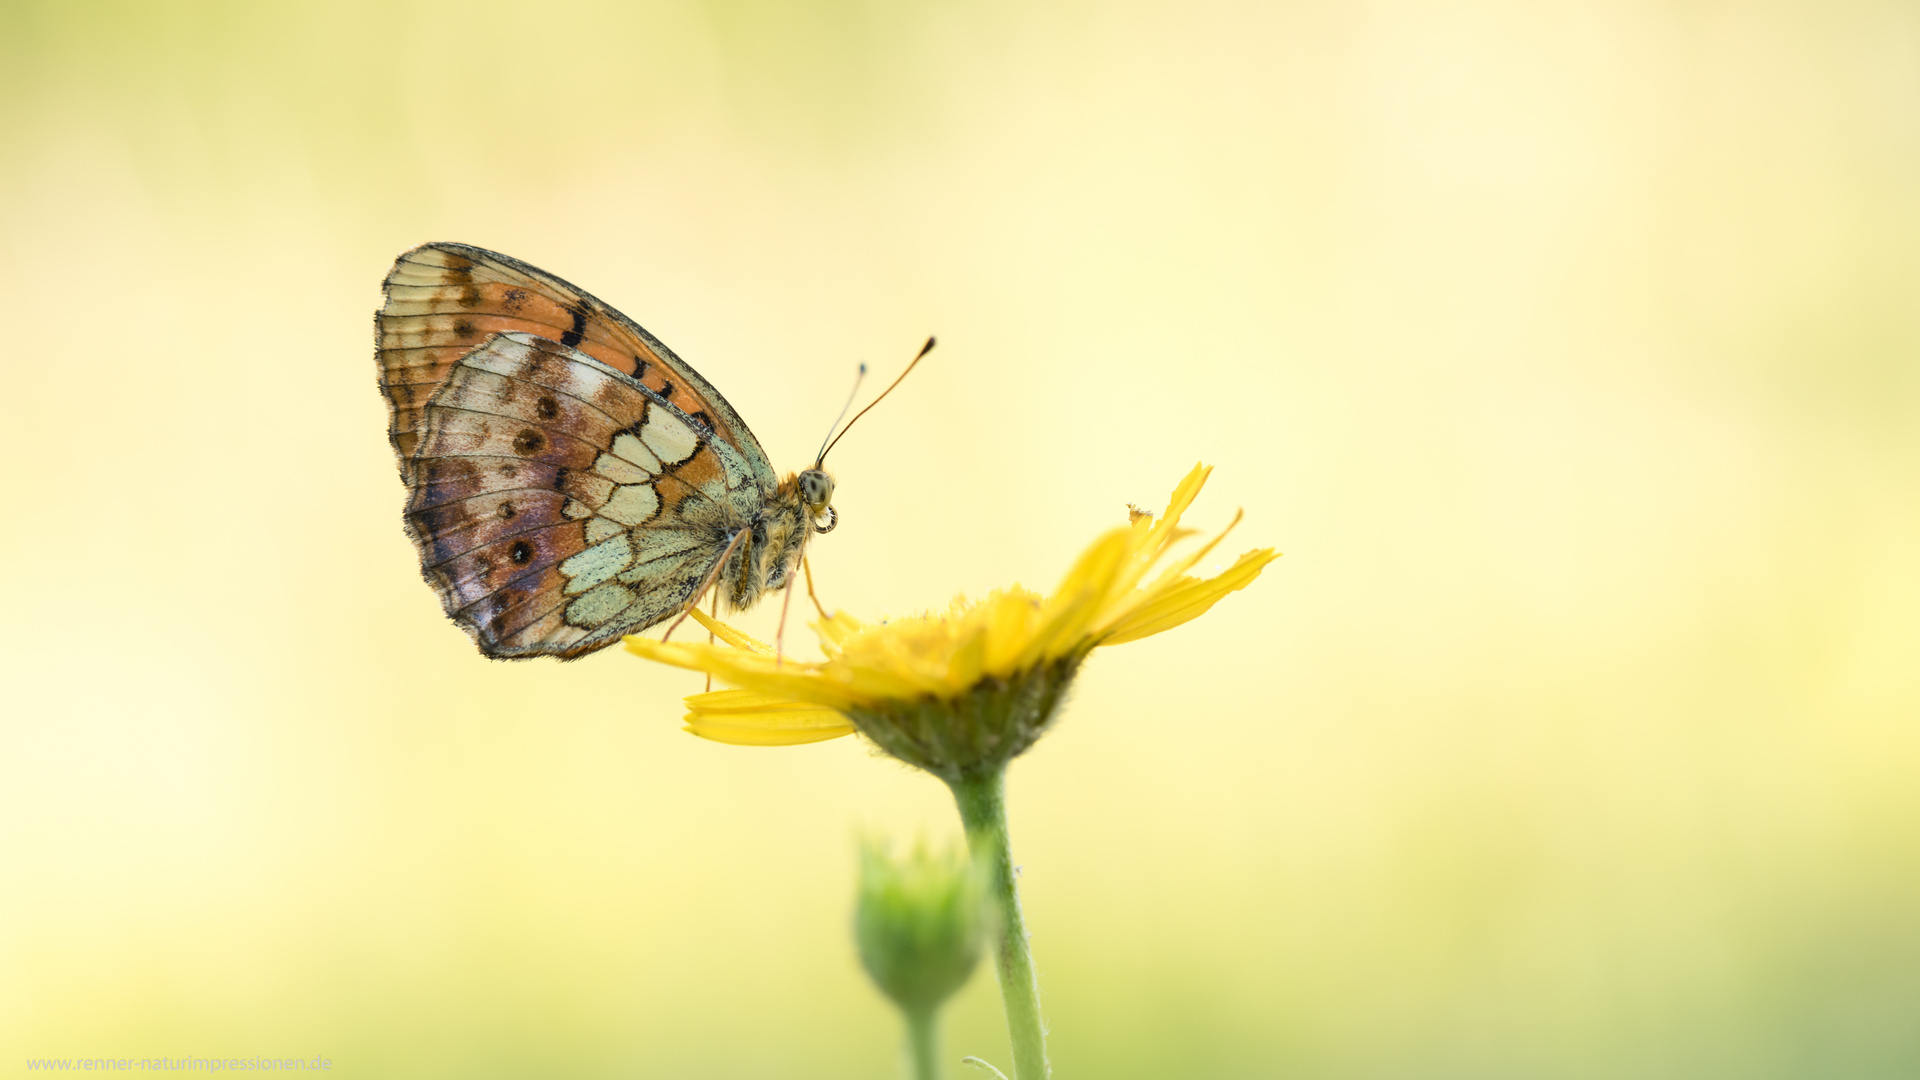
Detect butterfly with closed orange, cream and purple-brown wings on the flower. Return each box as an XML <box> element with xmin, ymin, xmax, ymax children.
<box><xmin>374</xmin><ymin>244</ymin><xmax>917</xmax><ymax>659</ymax></box>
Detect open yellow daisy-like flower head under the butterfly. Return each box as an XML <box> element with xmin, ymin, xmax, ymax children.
<box><xmin>626</xmin><ymin>465</ymin><xmax>1277</xmax><ymax>780</ymax></box>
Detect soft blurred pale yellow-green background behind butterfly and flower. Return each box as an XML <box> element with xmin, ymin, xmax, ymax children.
<box><xmin>0</xmin><ymin>0</ymin><xmax>1920</xmax><ymax>1080</ymax></box>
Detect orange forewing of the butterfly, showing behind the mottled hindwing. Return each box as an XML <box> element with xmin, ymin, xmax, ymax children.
<box><xmin>374</xmin><ymin>244</ymin><xmax>778</xmax><ymax>490</ymax></box>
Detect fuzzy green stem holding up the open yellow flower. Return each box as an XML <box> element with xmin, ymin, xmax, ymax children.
<box><xmin>948</xmin><ymin>765</ymin><xmax>1048</xmax><ymax>1080</ymax></box>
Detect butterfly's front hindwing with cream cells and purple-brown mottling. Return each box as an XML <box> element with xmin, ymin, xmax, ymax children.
<box><xmin>407</xmin><ymin>334</ymin><xmax>766</xmax><ymax>659</ymax></box>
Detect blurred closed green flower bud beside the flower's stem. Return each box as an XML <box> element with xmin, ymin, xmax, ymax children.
<box><xmin>852</xmin><ymin>840</ymin><xmax>987</xmax><ymax>1019</ymax></box>
